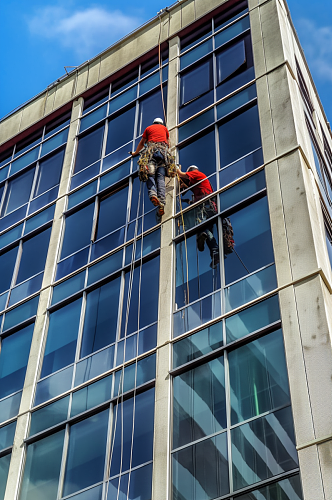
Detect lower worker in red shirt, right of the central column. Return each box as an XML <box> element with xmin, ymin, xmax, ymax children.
<box><xmin>176</xmin><ymin>165</ymin><xmax>219</xmax><ymax>269</ymax></box>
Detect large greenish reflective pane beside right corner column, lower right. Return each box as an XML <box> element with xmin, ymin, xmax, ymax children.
<box><xmin>228</xmin><ymin>330</ymin><xmax>290</xmax><ymax>424</ymax></box>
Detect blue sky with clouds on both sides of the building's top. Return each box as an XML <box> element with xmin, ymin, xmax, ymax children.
<box><xmin>0</xmin><ymin>0</ymin><xmax>332</xmax><ymax>122</ymax></box>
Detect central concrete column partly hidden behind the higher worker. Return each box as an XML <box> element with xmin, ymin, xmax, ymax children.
<box><xmin>152</xmin><ymin>37</ymin><xmax>179</xmax><ymax>500</ymax></box>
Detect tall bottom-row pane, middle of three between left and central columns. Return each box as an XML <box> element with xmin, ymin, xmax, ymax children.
<box><xmin>63</xmin><ymin>410</ymin><xmax>109</xmax><ymax>496</ymax></box>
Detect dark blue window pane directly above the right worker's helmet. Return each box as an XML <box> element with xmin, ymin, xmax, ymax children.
<box><xmin>179</xmin><ymin>130</ymin><xmax>216</xmax><ymax>175</ymax></box>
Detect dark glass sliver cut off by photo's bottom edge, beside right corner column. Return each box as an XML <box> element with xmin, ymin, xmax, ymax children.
<box><xmin>236</xmin><ymin>476</ymin><xmax>303</xmax><ymax>500</ymax></box>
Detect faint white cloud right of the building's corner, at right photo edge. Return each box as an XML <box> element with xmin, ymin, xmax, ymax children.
<box><xmin>296</xmin><ymin>19</ymin><xmax>332</xmax><ymax>83</ymax></box>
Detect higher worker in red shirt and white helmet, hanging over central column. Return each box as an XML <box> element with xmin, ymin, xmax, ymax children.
<box><xmin>131</xmin><ymin>118</ymin><xmax>169</xmax><ymax>217</ymax></box>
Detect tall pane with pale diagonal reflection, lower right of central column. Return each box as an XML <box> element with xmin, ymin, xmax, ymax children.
<box><xmin>173</xmin><ymin>356</ymin><xmax>226</xmax><ymax>448</ymax></box>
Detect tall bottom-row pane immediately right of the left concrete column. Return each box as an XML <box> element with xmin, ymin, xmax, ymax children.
<box><xmin>20</xmin><ymin>430</ymin><xmax>65</xmax><ymax>500</ymax></box>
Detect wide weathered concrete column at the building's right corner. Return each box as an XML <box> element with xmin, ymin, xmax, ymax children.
<box><xmin>249</xmin><ymin>0</ymin><xmax>332</xmax><ymax>500</ymax></box>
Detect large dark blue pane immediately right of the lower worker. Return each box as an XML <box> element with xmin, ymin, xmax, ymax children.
<box><xmin>224</xmin><ymin>197</ymin><xmax>274</xmax><ymax>284</ymax></box>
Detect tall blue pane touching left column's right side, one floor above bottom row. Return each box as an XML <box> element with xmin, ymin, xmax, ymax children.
<box><xmin>41</xmin><ymin>299</ymin><xmax>81</xmax><ymax>378</ymax></box>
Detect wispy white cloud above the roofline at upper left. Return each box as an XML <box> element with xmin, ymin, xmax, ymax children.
<box><xmin>28</xmin><ymin>6</ymin><xmax>142</xmax><ymax>58</ymax></box>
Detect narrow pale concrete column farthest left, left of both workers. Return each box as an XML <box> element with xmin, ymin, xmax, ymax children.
<box><xmin>4</xmin><ymin>98</ymin><xmax>83</xmax><ymax>500</ymax></box>
